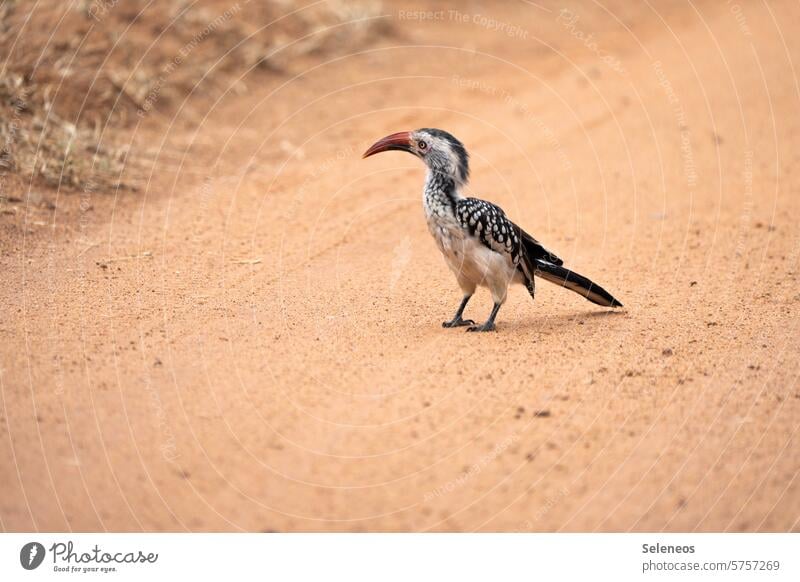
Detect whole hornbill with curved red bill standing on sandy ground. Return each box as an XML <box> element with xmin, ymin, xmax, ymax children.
<box><xmin>363</xmin><ymin>128</ymin><xmax>622</xmax><ymax>331</ymax></box>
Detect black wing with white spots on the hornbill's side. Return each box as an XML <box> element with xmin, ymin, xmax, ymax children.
<box><xmin>456</xmin><ymin>198</ymin><xmax>564</xmax><ymax>265</ymax></box>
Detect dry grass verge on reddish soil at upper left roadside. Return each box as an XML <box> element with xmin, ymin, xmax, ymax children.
<box><xmin>0</xmin><ymin>0</ymin><xmax>383</xmax><ymax>196</ymax></box>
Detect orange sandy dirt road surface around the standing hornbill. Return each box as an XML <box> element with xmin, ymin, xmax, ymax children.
<box><xmin>0</xmin><ymin>2</ymin><xmax>800</xmax><ymax>531</ymax></box>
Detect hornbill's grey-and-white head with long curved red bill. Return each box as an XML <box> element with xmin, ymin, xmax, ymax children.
<box><xmin>364</xmin><ymin>128</ymin><xmax>469</xmax><ymax>185</ymax></box>
